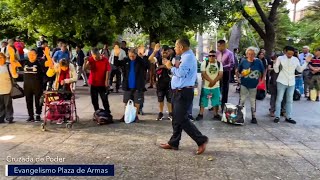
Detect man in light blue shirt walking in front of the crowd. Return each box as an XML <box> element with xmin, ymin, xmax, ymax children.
<box><xmin>160</xmin><ymin>39</ymin><xmax>209</xmax><ymax>154</ymax></box>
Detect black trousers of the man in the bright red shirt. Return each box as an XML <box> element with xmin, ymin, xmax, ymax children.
<box><xmin>90</xmin><ymin>86</ymin><xmax>111</xmax><ymax>114</ymax></box>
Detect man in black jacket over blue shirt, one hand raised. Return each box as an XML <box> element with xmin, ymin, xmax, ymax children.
<box><xmin>114</xmin><ymin>49</ymin><xmax>149</xmax><ymax>122</ymax></box>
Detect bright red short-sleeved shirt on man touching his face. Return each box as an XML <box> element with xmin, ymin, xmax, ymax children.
<box><xmin>88</xmin><ymin>57</ymin><xmax>111</xmax><ymax>86</ymax></box>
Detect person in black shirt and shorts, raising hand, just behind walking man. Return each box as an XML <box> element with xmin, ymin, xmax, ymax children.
<box><xmin>149</xmin><ymin>43</ymin><xmax>172</xmax><ymax>121</ymax></box>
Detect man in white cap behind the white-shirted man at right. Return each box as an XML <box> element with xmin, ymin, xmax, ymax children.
<box><xmin>299</xmin><ymin>46</ymin><xmax>310</xmax><ymax>98</ymax></box>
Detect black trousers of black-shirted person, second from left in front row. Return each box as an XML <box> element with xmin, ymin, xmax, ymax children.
<box><xmin>24</xmin><ymin>82</ymin><xmax>43</xmax><ymax>117</ymax></box>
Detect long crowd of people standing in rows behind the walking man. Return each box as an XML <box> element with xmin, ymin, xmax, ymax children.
<box><xmin>0</xmin><ymin>37</ymin><xmax>320</xmax><ymax>127</ymax></box>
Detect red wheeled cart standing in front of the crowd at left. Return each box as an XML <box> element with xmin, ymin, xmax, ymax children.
<box><xmin>41</xmin><ymin>88</ymin><xmax>79</xmax><ymax>131</ymax></box>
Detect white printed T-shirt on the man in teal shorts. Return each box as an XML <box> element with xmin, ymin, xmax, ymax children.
<box><xmin>200</xmin><ymin>61</ymin><xmax>223</xmax><ymax>89</ymax></box>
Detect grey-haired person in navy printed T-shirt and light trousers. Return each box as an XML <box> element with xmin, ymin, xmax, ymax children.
<box><xmin>237</xmin><ymin>47</ymin><xmax>265</xmax><ymax>124</ymax></box>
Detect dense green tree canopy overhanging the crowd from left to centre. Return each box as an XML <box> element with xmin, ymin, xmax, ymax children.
<box><xmin>0</xmin><ymin>0</ymin><xmax>231</xmax><ymax>45</ymax></box>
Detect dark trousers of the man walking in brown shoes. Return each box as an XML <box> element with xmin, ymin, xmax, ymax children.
<box><xmin>168</xmin><ymin>88</ymin><xmax>208</xmax><ymax>147</ymax></box>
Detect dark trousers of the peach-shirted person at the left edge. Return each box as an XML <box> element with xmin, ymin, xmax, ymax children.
<box><xmin>0</xmin><ymin>94</ymin><xmax>13</xmax><ymax>122</ymax></box>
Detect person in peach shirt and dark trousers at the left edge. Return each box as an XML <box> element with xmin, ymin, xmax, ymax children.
<box><xmin>0</xmin><ymin>52</ymin><xmax>18</xmax><ymax>124</ymax></box>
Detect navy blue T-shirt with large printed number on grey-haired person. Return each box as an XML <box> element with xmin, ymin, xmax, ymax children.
<box><xmin>238</xmin><ymin>59</ymin><xmax>264</xmax><ymax>89</ymax></box>
